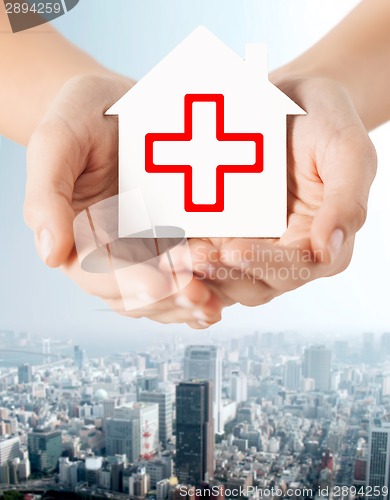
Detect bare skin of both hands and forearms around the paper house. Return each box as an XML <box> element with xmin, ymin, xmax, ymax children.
<box><xmin>0</xmin><ymin>0</ymin><xmax>390</xmax><ymax>328</ymax></box>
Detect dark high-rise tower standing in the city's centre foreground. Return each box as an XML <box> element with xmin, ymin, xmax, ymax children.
<box><xmin>176</xmin><ymin>381</ymin><xmax>214</xmax><ymax>485</ymax></box>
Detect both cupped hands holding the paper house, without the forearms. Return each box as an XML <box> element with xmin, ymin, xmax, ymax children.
<box><xmin>25</xmin><ymin>74</ymin><xmax>376</xmax><ymax>328</ymax></box>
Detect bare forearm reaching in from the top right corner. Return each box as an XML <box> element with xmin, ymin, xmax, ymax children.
<box><xmin>271</xmin><ymin>0</ymin><xmax>390</xmax><ymax>130</ymax></box>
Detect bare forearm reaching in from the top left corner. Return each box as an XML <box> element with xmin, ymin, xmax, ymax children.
<box><xmin>0</xmin><ymin>7</ymin><xmax>119</xmax><ymax>144</ymax></box>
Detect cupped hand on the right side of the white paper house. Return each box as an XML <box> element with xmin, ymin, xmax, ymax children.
<box><xmin>186</xmin><ymin>77</ymin><xmax>376</xmax><ymax>306</ymax></box>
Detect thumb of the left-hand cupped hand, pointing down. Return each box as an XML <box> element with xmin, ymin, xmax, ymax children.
<box><xmin>24</xmin><ymin>123</ymin><xmax>79</xmax><ymax>267</ymax></box>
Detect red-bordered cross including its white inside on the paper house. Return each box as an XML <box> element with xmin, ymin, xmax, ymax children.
<box><xmin>145</xmin><ymin>94</ymin><xmax>264</xmax><ymax>212</ymax></box>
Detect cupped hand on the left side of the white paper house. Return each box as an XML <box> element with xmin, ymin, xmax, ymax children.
<box><xmin>24</xmin><ymin>74</ymin><xmax>222</xmax><ymax>328</ymax></box>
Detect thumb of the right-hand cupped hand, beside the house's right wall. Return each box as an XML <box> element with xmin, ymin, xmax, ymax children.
<box><xmin>311</xmin><ymin>129</ymin><xmax>376</xmax><ymax>264</ymax></box>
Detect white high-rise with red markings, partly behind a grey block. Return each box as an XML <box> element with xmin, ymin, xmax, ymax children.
<box><xmin>114</xmin><ymin>402</ymin><xmax>159</xmax><ymax>458</ymax></box>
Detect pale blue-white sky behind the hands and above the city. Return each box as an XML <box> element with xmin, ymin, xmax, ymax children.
<box><xmin>0</xmin><ymin>0</ymin><xmax>390</xmax><ymax>348</ymax></box>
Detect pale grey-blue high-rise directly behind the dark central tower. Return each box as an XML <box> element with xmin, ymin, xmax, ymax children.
<box><xmin>184</xmin><ymin>345</ymin><xmax>224</xmax><ymax>434</ymax></box>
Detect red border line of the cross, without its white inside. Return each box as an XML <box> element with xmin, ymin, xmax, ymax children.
<box><xmin>145</xmin><ymin>94</ymin><xmax>264</xmax><ymax>212</ymax></box>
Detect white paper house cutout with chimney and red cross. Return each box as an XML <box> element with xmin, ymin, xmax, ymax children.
<box><xmin>106</xmin><ymin>26</ymin><xmax>305</xmax><ymax>237</ymax></box>
